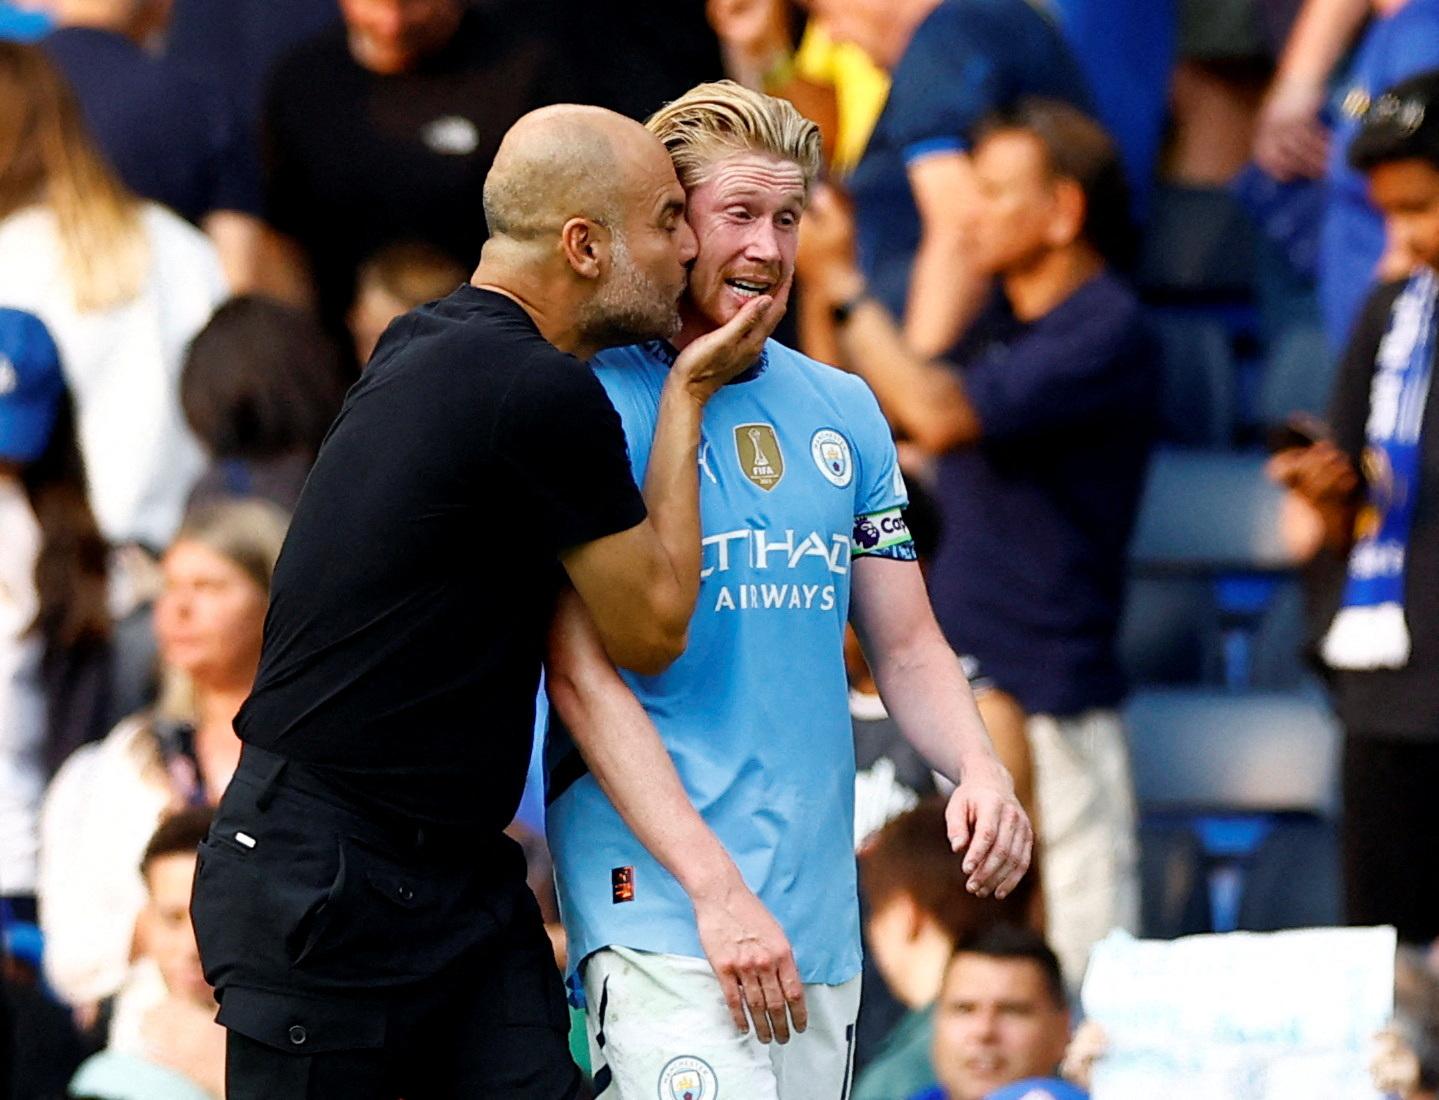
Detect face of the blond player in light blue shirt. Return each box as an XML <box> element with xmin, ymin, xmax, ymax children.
<box><xmin>685</xmin><ymin>153</ymin><xmax>804</xmax><ymax>330</ymax></box>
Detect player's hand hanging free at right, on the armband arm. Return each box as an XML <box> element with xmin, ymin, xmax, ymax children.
<box><xmin>944</xmin><ymin>760</ymin><xmax>1035</xmax><ymax>897</ymax></box>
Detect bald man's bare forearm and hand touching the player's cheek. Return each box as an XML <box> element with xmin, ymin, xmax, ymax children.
<box><xmin>560</xmin><ymin>297</ymin><xmax>783</xmax><ymax>675</ymax></box>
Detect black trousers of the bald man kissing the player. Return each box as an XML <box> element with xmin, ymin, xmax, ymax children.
<box><xmin>191</xmin><ymin>747</ymin><xmax>580</xmax><ymax>1100</ymax></box>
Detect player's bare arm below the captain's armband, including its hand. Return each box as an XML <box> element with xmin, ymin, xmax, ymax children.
<box><xmin>853</xmin><ymin>556</ymin><xmax>1035</xmax><ymax>897</ymax></box>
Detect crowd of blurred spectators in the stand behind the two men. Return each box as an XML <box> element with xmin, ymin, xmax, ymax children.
<box><xmin>0</xmin><ymin>0</ymin><xmax>1439</xmax><ymax>1100</ymax></box>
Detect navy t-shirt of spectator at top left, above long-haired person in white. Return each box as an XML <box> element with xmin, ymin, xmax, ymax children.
<box><xmin>42</xmin><ymin>27</ymin><xmax>260</xmax><ymax>223</ymax></box>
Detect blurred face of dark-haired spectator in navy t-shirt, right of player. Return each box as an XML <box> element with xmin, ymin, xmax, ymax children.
<box><xmin>968</xmin><ymin>130</ymin><xmax>1055</xmax><ymax>275</ymax></box>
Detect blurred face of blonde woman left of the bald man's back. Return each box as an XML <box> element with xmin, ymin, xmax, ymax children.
<box><xmin>155</xmin><ymin>540</ymin><xmax>266</xmax><ymax>688</ymax></box>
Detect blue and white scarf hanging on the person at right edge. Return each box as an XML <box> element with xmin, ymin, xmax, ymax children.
<box><xmin>1321</xmin><ymin>268</ymin><xmax>1439</xmax><ymax>670</ymax></box>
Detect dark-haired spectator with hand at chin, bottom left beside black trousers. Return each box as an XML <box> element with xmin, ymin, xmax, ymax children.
<box><xmin>69</xmin><ymin>808</ymin><xmax>224</xmax><ymax>1100</ymax></box>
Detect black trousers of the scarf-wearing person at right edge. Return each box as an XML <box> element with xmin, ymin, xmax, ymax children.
<box><xmin>1340</xmin><ymin>733</ymin><xmax>1439</xmax><ymax>945</ymax></box>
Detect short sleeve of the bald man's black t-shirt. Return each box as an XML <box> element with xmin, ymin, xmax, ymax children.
<box><xmin>495</xmin><ymin>356</ymin><xmax>646</xmax><ymax>553</ymax></box>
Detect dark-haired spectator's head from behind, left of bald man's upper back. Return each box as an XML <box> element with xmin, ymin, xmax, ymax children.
<box><xmin>180</xmin><ymin>297</ymin><xmax>350</xmax><ymax>511</ymax></box>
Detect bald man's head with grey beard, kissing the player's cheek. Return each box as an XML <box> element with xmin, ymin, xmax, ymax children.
<box><xmin>484</xmin><ymin>104</ymin><xmax>695</xmax><ymax>347</ymax></box>
